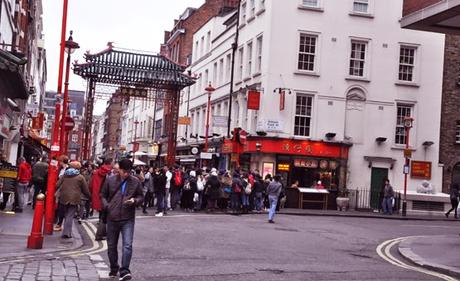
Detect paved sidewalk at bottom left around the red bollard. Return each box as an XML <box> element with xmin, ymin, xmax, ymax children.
<box><xmin>0</xmin><ymin>206</ymin><xmax>99</xmax><ymax>281</ymax></box>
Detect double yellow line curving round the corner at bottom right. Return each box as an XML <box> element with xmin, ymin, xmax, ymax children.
<box><xmin>376</xmin><ymin>236</ymin><xmax>458</xmax><ymax>281</ymax></box>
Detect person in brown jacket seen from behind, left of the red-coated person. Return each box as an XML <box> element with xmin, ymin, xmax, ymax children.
<box><xmin>56</xmin><ymin>161</ymin><xmax>90</xmax><ymax>239</ymax></box>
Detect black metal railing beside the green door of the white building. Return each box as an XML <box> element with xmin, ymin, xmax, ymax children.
<box><xmin>348</xmin><ymin>189</ymin><xmax>401</xmax><ymax>213</ymax></box>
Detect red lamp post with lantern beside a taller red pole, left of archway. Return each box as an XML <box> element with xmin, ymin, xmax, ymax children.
<box><xmin>59</xmin><ymin>31</ymin><xmax>80</xmax><ymax>154</ymax></box>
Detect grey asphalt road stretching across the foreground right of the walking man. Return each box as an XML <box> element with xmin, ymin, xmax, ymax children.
<box><xmin>91</xmin><ymin>213</ymin><xmax>460</xmax><ymax>281</ymax></box>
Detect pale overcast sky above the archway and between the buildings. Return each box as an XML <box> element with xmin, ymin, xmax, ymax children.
<box><xmin>43</xmin><ymin>0</ymin><xmax>204</xmax><ymax>113</ymax></box>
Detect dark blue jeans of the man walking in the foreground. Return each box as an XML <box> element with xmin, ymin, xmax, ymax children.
<box><xmin>107</xmin><ymin>219</ymin><xmax>134</xmax><ymax>275</ymax></box>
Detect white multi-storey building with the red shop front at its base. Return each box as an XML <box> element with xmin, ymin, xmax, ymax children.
<box><xmin>179</xmin><ymin>0</ymin><xmax>444</xmax><ymax>203</ymax></box>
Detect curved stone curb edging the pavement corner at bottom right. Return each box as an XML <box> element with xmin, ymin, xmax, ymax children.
<box><xmin>398</xmin><ymin>234</ymin><xmax>460</xmax><ymax>278</ymax></box>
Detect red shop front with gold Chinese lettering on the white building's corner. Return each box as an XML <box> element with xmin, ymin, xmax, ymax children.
<box><xmin>223</xmin><ymin>137</ymin><xmax>350</xmax><ymax>208</ymax></box>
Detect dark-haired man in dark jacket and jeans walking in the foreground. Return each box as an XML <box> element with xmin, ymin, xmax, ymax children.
<box><xmin>101</xmin><ymin>159</ymin><xmax>143</xmax><ymax>281</ymax></box>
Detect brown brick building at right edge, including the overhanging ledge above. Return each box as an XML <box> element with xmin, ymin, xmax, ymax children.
<box><xmin>401</xmin><ymin>0</ymin><xmax>460</xmax><ymax>192</ymax></box>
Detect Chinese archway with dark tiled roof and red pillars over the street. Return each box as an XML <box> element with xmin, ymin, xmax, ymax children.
<box><xmin>74</xmin><ymin>44</ymin><xmax>195</xmax><ymax>165</ymax></box>
